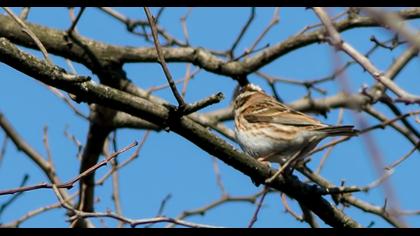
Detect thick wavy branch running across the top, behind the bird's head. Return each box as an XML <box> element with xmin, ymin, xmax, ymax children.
<box><xmin>0</xmin><ymin>8</ymin><xmax>420</xmax><ymax>77</ymax></box>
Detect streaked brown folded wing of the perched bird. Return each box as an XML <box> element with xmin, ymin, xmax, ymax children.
<box><xmin>244</xmin><ymin>98</ymin><xmax>323</xmax><ymax>126</ymax></box>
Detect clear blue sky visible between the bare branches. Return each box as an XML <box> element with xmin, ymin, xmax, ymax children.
<box><xmin>0</xmin><ymin>7</ymin><xmax>420</xmax><ymax>227</ymax></box>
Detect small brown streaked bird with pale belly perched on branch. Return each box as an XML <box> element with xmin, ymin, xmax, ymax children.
<box><xmin>233</xmin><ymin>83</ymin><xmax>359</xmax><ymax>183</ymax></box>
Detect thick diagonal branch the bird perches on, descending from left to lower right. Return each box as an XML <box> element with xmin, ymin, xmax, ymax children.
<box><xmin>0</xmin><ymin>38</ymin><xmax>360</xmax><ymax>227</ymax></box>
